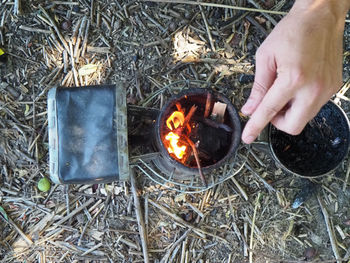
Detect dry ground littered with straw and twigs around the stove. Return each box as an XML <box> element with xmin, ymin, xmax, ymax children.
<box><xmin>0</xmin><ymin>0</ymin><xmax>350</xmax><ymax>262</ymax></box>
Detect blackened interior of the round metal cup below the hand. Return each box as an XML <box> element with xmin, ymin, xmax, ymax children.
<box><xmin>269</xmin><ymin>102</ymin><xmax>349</xmax><ymax>177</ymax></box>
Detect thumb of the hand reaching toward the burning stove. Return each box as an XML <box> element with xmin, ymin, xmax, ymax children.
<box><xmin>241</xmin><ymin>49</ymin><xmax>277</xmax><ymax>115</ymax></box>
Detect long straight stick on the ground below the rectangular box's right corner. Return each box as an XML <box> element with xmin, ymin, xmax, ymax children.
<box><xmin>130</xmin><ymin>169</ymin><xmax>150</xmax><ymax>263</ymax></box>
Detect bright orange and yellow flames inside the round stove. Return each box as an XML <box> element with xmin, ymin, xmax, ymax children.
<box><xmin>165</xmin><ymin>111</ymin><xmax>187</xmax><ymax>159</ymax></box>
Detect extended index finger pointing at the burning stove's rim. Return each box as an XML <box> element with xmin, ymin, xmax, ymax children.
<box><xmin>242</xmin><ymin>78</ymin><xmax>293</xmax><ymax>144</ymax></box>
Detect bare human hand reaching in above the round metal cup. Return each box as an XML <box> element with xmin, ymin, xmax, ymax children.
<box><xmin>241</xmin><ymin>0</ymin><xmax>350</xmax><ymax>143</ymax></box>
